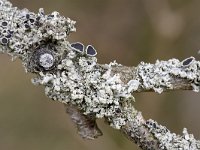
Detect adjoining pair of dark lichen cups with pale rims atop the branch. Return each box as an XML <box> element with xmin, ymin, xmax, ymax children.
<box><xmin>70</xmin><ymin>42</ymin><xmax>97</xmax><ymax>56</ymax></box>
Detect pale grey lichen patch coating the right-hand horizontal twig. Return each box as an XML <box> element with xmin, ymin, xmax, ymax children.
<box><xmin>137</xmin><ymin>57</ymin><xmax>200</xmax><ymax>93</ymax></box>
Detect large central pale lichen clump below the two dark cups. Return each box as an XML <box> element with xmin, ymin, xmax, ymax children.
<box><xmin>34</xmin><ymin>49</ymin><xmax>139</xmax><ymax>129</ymax></box>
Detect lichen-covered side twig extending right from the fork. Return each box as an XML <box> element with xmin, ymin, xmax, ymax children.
<box><xmin>113</xmin><ymin>57</ymin><xmax>200</xmax><ymax>93</ymax></box>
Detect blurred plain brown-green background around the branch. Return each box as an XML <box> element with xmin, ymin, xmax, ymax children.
<box><xmin>0</xmin><ymin>0</ymin><xmax>200</xmax><ymax>150</ymax></box>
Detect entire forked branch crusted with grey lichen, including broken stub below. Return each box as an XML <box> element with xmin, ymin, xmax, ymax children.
<box><xmin>0</xmin><ymin>0</ymin><xmax>200</xmax><ymax>150</ymax></box>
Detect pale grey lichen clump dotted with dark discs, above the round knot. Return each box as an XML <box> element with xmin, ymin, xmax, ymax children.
<box><xmin>0</xmin><ymin>0</ymin><xmax>75</xmax><ymax>59</ymax></box>
